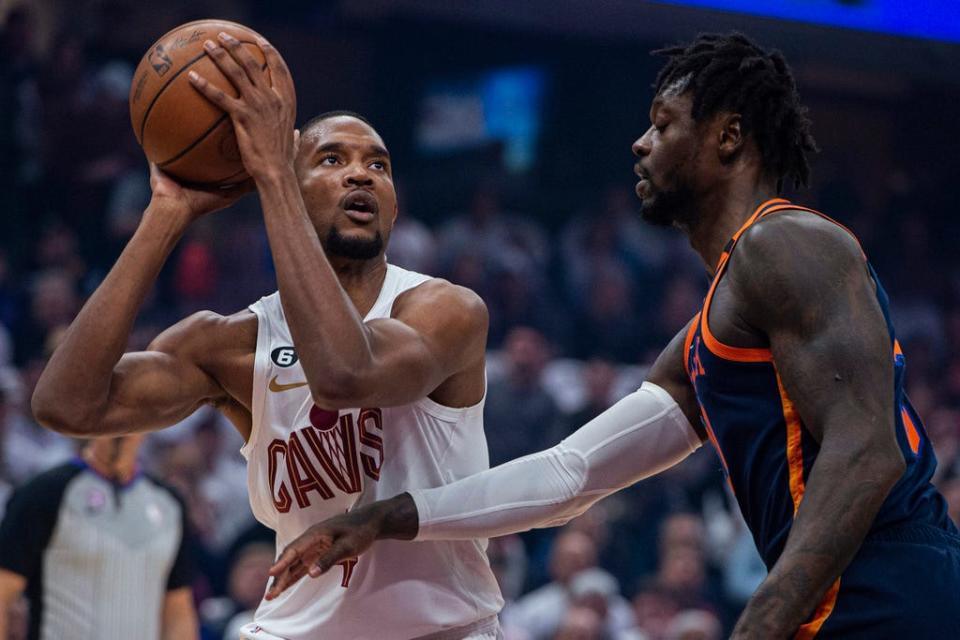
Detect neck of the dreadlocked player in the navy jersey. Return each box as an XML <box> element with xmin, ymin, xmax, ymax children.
<box><xmin>686</xmin><ymin>178</ymin><xmax>777</xmax><ymax>274</ymax></box>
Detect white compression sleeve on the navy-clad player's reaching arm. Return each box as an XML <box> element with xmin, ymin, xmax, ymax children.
<box><xmin>409</xmin><ymin>382</ymin><xmax>700</xmax><ymax>540</ymax></box>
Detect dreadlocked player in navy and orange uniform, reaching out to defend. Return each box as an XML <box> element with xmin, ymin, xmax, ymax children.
<box><xmin>268</xmin><ymin>34</ymin><xmax>960</xmax><ymax>640</ymax></box>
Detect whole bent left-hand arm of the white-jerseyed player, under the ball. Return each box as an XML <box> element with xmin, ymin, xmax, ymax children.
<box><xmin>32</xmin><ymin>167</ymin><xmax>250</xmax><ymax>436</ymax></box>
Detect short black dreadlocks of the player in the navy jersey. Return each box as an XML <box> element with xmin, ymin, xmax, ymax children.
<box><xmin>653</xmin><ymin>32</ymin><xmax>818</xmax><ymax>192</ymax></box>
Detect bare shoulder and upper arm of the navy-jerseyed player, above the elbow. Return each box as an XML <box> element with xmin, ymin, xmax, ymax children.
<box><xmin>730</xmin><ymin>218</ymin><xmax>893</xmax><ymax>441</ymax></box>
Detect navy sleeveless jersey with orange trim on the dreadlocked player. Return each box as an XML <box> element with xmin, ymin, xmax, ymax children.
<box><xmin>685</xmin><ymin>200</ymin><xmax>946</xmax><ymax>565</ymax></box>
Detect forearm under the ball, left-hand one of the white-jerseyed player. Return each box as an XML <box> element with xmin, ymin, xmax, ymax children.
<box><xmin>32</xmin><ymin>204</ymin><xmax>183</xmax><ymax>435</ymax></box>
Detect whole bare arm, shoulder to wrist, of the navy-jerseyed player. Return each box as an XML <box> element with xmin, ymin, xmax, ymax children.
<box><xmin>727</xmin><ymin>212</ymin><xmax>904</xmax><ymax>639</ymax></box>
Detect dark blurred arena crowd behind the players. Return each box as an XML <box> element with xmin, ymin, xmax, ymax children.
<box><xmin>0</xmin><ymin>0</ymin><xmax>960</xmax><ymax>640</ymax></box>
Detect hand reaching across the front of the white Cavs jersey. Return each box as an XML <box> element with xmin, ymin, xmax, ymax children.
<box><xmin>266</xmin><ymin>503</ymin><xmax>383</xmax><ymax>600</ymax></box>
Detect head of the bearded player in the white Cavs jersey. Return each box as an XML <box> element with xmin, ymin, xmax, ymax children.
<box><xmin>296</xmin><ymin>111</ymin><xmax>397</xmax><ymax>260</ymax></box>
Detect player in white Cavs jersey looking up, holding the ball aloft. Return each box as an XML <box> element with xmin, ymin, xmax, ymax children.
<box><xmin>33</xmin><ymin>34</ymin><xmax>502</xmax><ymax>640</ymax></box>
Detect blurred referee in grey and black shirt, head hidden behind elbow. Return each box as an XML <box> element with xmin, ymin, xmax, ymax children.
<box><xmin>0</xmin><ymin>435</ymin><xmax>198</xmax><ymax>640</ymax></box>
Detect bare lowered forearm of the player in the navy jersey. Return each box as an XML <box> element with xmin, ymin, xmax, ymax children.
<box><xmin>732</xmin><ymin>432</ymin><xmax>903</xmax><ymax>640</ymax></box>
